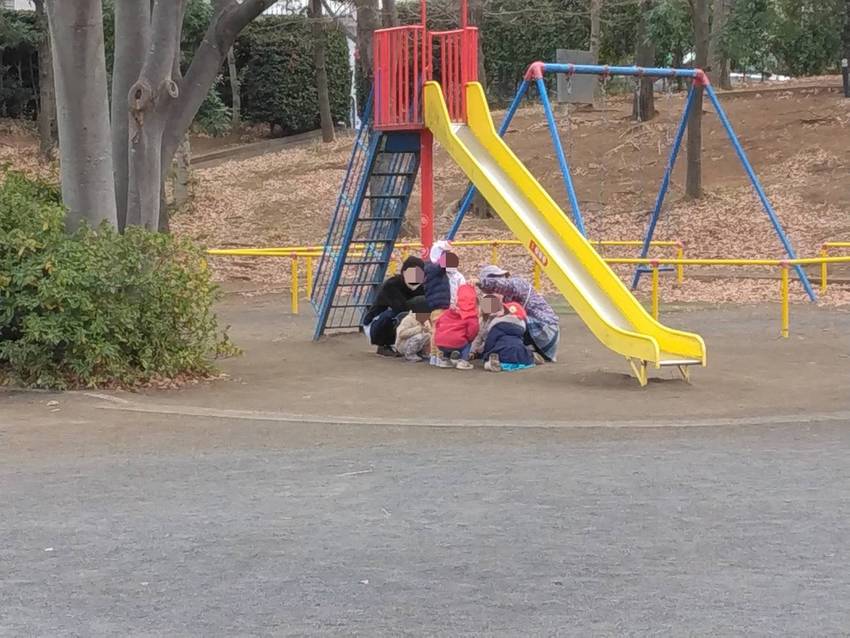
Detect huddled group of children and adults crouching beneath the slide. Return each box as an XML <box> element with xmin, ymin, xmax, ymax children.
<box><xmin>363</xmin><ymin>241</ymin><xmax>559</xmax><ymax>372</ymax></box>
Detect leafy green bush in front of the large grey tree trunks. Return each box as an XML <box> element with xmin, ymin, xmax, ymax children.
<box><xmin>0</xmin><ymin>173</ymin><xmax>229</xmax><ymax>388</ymax></box>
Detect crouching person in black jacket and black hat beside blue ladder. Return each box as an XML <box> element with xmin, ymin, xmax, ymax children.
<box><xmin>363</xmin><ymin>256</ymin><xmax>425</xmax><ymax>356</ymax></box>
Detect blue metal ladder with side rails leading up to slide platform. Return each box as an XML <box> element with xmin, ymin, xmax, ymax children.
<box><xmin>310</xmin><ymin>106</ymin><xmax>419</xmax><ymax>340</ymax></box>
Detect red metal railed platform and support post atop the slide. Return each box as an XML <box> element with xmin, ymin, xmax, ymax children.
<box><xmin>373</xmin><ymin>0</ymin><xmax>478</xmax><ymax>250</ymax></box>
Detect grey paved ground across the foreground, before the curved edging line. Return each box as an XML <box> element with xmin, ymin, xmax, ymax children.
<box><xmin>0</xmin><ymin>413</ymin><xmax>850</xmax><ymax>637</ymax></box>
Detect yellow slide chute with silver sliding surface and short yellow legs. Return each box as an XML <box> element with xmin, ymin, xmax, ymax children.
<box><xmin>424</xmin><ymin>82</ymin><xmax>706</xmax><ymax>385</ymax></box>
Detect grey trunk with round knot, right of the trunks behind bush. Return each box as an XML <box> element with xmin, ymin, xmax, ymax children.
<box><xmin>127</xmin><ymin>0</ymin><xmax>186</xmax><ymax>231</ymax></box>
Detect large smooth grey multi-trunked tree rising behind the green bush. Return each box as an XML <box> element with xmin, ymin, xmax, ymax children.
<box><xmin>47</xmin><ymin>0</ymin><xmax>272</xmax><ymax>230</ymax></box>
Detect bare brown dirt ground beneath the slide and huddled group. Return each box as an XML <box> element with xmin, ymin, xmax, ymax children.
<box><xmin>48</xmin><ymin>294</ymin><xmax>850</xmax><ymax>426</ymax></box>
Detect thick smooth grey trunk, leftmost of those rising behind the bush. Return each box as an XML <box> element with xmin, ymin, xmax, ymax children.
<box><xmin>46</xmin><ymin>0</ymin><xmax>117</xmax><ymax>229</ymax></box>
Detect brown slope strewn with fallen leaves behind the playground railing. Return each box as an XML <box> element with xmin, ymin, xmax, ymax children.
<box><xmin>0</xmin><ymin>78</ymin><xmax>850</xmax><ymax>305</ymax></box>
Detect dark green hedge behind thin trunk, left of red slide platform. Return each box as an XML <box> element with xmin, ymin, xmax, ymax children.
<box><xmin>235</xmin><ymin>16</ymin><xmax>351</xmax><ymax>135</ymax></box>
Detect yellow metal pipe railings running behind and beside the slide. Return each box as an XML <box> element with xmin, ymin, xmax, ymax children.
<box><xmin>207</xmin><ymin>239</ymin><xmax>850</xmax><ymax>338</ymax></box>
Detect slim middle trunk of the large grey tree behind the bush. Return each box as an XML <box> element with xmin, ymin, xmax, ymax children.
<box><xmin>112</xmin><ymin>0</ymin><xmax>151</xmax><ymax>230</ymax></box>
